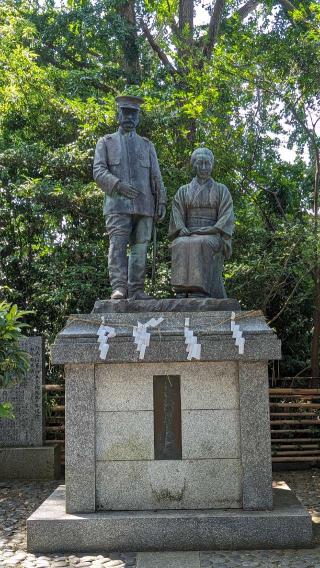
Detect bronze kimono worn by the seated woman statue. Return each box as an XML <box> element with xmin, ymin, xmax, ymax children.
<box><xmin>169</xmin><ymin>178</ymin><xmax>234</xmax><ymax>298</ymax></box>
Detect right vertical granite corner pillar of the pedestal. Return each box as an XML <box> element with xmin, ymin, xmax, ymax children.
<box><xmin>239</xmin><ymin>362</ymin><xmax>272</xmax><ymax>510</ymax></box>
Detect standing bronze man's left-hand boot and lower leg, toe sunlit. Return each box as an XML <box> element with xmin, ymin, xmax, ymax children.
<box><xmin>108</xmin><ymin>237</ymin><xmax>128</xmax><ymax>300</ymax></box>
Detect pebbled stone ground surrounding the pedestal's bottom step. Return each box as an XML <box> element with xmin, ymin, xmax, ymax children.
<box><xmin>0</xmin><ymin>469</ymin><xmax>320</xmax><ymax>568</ymax></box>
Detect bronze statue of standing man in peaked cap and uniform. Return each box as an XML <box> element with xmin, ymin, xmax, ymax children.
<box><xmin>93</xmin><ymin>96</ymin><xmax>167</xmax><ymax>300</ymax></box>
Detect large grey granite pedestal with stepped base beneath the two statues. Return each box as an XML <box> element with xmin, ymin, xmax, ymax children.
<box><xmin>27</xmin><ymin>301</ymin><xmax>311</xmax><ymax>552</ymax></box>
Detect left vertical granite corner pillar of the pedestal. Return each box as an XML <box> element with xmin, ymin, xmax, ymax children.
<box><xmin>65</xmin><ymin>365</ymin><xmax>95</xmax><ymax>513</ymax></box>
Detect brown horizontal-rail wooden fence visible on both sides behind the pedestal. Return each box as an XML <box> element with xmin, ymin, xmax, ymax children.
<box><xmin>44</xmin><ymin>385</ymin><xmax>320</xmax><ymax>464</ymax></box>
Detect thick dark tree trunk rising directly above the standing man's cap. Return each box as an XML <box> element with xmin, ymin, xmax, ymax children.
<box><xmin>119</xmin><ymin>0</ymin><xmax>140</xmax><ymax>85</ymax></box>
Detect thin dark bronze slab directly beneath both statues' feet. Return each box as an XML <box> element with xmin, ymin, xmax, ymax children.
<box><xmin>92</xmin><ymin>298</ymin><xmax>241</xmax><ymax>314</ymax></box>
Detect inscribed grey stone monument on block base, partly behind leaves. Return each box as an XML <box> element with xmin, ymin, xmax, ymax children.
<box><xmin>0</xmin><ymin>337</ymin><xmax>60</xmax><ymax>479</ymax></box>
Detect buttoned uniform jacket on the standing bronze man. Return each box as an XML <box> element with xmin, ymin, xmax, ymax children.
<box><xmin>93</xmin><ymin>130</ymin><xmax>166</xmax><ymax>217</ymax></box>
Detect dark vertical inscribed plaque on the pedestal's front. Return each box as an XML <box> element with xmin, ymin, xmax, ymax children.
<box><xmin>153</xmin><ymin>375</ymin><xmax>182</xmax><ymax>460</ymax></box>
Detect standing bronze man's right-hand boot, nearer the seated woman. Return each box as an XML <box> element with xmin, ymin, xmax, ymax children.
<box><xmin>128</xmin><ymin>243</ymin><xmax>152</xmax><ymax>300</ymax></box>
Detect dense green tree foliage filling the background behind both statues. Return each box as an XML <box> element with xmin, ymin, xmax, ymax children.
<box><xmin>0</xmin><ymin>0</ymin><xmax>320</xmax><ymax>382</ymax></box>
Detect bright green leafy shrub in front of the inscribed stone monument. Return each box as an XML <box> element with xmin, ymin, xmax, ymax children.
<box><xmin>0</xmin><ymin>302</ymin><xmax>29</xmax><ymax>418</ymax></box>
